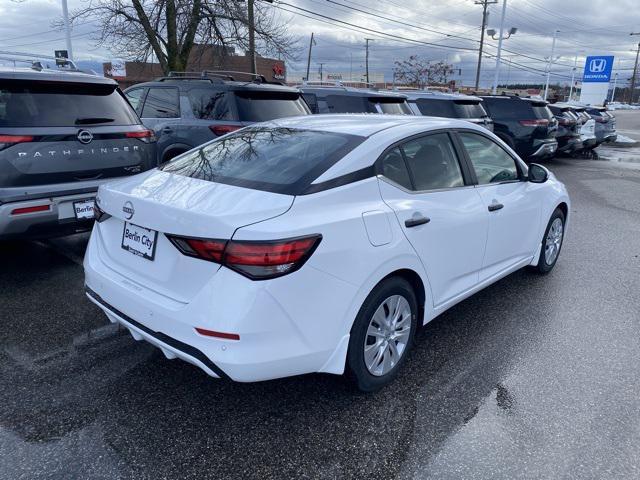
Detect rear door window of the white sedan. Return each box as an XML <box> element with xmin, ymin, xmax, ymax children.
<box><xmin>402</xmin><ymin>133</ymin><xmax>464</xmax><ymax>190</ymax></box>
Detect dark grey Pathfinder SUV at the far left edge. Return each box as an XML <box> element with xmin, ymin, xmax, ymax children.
<box><xmin>0</xmin><ymin>68</ymin><xmax>156</xmax><ymax>240</ymax></box>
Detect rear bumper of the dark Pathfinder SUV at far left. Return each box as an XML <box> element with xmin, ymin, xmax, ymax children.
<box><xmin>0</xmin><ymin>187</ymin><xmax>97</xmax><ymax>240</ymax></box>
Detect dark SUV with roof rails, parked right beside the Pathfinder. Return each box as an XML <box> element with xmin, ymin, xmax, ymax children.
<box><xmin>124</xmin><ymin>71</ymin><xmax>311</xmax><ymax>163</ymax></box>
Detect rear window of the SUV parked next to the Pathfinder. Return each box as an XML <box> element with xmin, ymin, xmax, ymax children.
<box><xmin>235</xmin><ymin>91</ymin><xmax>310</xmax><ymax>122</ymax></box>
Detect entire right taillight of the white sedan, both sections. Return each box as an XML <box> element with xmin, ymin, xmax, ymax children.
<box><xmin>167</xmin><ymin>235</ymin><xmax>322</xmax><ymax>280</ymax></box>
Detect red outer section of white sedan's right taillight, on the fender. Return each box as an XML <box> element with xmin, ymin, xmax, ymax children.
<box><xmin>225</xmin><ymin>237</ymin><xmax>318</xmax><ymax>266</ymax></box>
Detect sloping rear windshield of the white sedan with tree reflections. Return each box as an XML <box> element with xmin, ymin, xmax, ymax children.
<box><xmin>161</xmin><ymin>127</ymin><xmax>364</xmax><ymax>195</ymax></box>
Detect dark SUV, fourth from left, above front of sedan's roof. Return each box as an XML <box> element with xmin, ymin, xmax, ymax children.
<box><xmin>404</xmin><ymin>91</ymin><xmax>493</xmax><ymax>132</ymax></box>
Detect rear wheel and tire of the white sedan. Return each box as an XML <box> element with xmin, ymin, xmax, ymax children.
<box><xmin>347</xmin><ymin>277</ymin><xmax>418</xmax><ymax>392</ymax></box>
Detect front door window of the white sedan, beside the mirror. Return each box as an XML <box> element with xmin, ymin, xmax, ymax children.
<box><xmin>459</xmin><ymin>132</ymin><xmax>518</xmax><ymax>185</ymax></box>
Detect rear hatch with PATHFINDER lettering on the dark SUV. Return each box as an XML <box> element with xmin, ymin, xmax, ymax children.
<box><xmin>0</xmin><ymin>79</ymin><xmax>155</xmax><ymax>187</ymax></box>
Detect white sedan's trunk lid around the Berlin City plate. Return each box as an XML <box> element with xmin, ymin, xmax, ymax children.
<box><xmin>96</xmin><ymin>170</ymin><xmax>295</xmax><ymax>302</ymax></box>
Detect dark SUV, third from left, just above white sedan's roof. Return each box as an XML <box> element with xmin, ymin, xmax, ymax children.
<box><xmin>300</xmin><ymin>85</ymin><xmax>413</xmax><ymax>115</ymax></box>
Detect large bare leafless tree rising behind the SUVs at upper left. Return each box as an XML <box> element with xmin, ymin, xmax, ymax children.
<box><xmin>56</xmin><ymin>0</ymin><xmax>295</xmax><ymax>72</ymax></box>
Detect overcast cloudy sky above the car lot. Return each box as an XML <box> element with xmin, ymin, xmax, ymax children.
<box><xmin>0</xmin><ymin>0</ymin><xmax>640</xmax><ymax>86</ymax></box>
